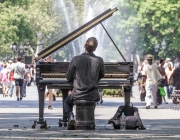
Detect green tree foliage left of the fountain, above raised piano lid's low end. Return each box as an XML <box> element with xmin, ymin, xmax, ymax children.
<box><xmin>0</xmin><ymin>0</ymin><xmax>55</xmax><ymax>57</ymax></box>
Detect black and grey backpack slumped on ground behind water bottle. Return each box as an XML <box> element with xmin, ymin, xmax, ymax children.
<box><xmin>108</xmin><ymin>103</ymin><xmax>146</xmax><ymax>130</ymax></box>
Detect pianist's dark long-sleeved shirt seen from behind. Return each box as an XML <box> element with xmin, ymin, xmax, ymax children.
<box><xmin>66</xmin><ymin>52</ymin><xmax>104</xmax><ymax>100</ymax></box>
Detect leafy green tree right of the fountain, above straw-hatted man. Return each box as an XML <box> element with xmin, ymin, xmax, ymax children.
<box><xmin>131</xmin><ymin>0</ymin><xmax>180</xmax><ymax>57</ymax></box>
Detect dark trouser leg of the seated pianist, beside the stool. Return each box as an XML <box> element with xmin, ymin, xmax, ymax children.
<box><xmin>64</xmin><ymin>94</ymin><xmax>73</xmax><ymax>117</ymax></box>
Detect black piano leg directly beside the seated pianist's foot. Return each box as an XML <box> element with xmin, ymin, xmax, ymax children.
<box><xmin>59</xmin><ymin>89</ymin><xmax>70</xmax><ymax>127</ymax></box>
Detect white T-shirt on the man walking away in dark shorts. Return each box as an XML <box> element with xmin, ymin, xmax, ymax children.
<box><xmin>12</xmin><ymin>62</ymin><xmax>25</xmax><ymax>79</ymax></box>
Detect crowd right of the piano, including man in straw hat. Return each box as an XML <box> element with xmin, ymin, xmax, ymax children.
<box><xmin>137</xmin><ymin>54</ymin><xmax>180</xmax><ymax>109</ymax></box>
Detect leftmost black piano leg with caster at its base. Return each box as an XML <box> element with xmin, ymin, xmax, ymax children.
<box><xmin>32</xmin><ymin>85</ymin><xmax>47</xmax><ymax>128</ymax></box>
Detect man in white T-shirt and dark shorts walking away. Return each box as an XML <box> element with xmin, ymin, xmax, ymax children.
<box><xmin>11</xmin><ymin>56</ymin><xmax>25</xmax><ymax>101</ymax></box>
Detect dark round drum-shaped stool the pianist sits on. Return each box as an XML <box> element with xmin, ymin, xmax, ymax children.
<box><xmin>73</xmin><ymin>100</ymin><xmax>96</xmax><ymax>130</ymax></box>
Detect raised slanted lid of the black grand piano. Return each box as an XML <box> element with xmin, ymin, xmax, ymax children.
<box><xmin>35</xmin><ymin>8</ymin><xmax>118</xmax><ymax>61</ymax></box>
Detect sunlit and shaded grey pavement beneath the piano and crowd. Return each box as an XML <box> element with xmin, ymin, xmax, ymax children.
<box><xmin>0</xmin><ymin>84</ymin><xmax>180</xmax><ymax>140</ymax></box>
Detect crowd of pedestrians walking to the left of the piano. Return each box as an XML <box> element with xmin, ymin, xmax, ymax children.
<box><xmin>0</xmin><ymin>57</ymin><xmax>36</xmax><ymax>101</ymax></box>
